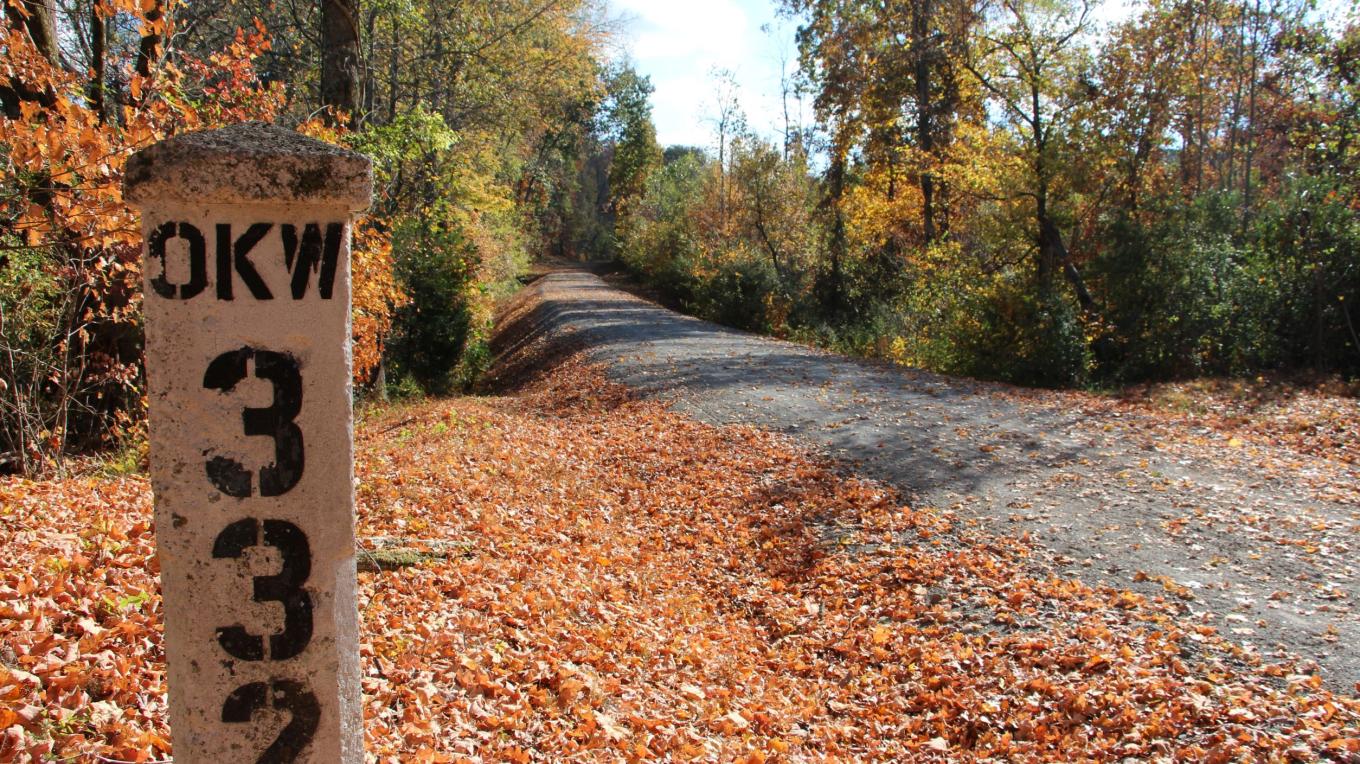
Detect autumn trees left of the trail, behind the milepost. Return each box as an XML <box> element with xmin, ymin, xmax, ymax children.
<box><xmin>0</xmin><ymin>0</ymin><xmax>620</xmax><ymax>472</ymax></box>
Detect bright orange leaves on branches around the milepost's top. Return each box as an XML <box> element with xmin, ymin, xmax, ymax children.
<box><xmin>0</xmin><ymin>6</ymin><xmax>404</xmax><ymax>382</ymax></box>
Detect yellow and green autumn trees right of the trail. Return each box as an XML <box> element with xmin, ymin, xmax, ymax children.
<box><xmin>616</xmin><ymin>0</ymin><xmax>1360</xmax><ymax>386</ymax></box>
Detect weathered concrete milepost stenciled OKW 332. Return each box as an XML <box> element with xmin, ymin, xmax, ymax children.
<box><xmin>125</xmin><ymin>122</ymin><xmax>373</xmax><ymax>764</ymax></box>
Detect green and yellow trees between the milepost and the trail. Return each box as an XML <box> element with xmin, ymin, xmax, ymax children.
<box><xmin>170</xmin><ymin>0</ymin><xmax>612</xmax><ymax>392</ymax></box>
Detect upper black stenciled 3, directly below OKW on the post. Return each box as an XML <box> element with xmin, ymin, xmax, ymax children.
<box><xmin>203</xmin><ymin>348</ymin><xmax>306</xmax><ymax>499</ymax></box>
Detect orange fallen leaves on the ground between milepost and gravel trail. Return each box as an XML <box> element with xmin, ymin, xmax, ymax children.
<box><xmin>363</xmin><ymin>363</ymin><xmax>1357</xmax><ymax>760</ymax></box>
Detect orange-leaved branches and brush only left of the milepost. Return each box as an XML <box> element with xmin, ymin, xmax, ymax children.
<box><xmin>0</xmin><ymin>5</ymin><xmax>283</xmax><ymax>469</ymax></box>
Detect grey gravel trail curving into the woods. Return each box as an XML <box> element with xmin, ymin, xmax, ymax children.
<box><xmin>498</xmin><ymin>271</ymin><xmax>1360</xmax><ymax>695</ymax></box>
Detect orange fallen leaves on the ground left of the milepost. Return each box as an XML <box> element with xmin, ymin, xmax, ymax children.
<box><xmin>0</xmin><ymin>476</ymin><xmax>170</xmax><ymax>761</ymax></box>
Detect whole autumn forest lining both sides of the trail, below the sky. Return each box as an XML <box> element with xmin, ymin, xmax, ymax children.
<box><xmin>0</xmin><ymin>0</ymin><xmax>1360</xmax><ymax>472</ymax></box>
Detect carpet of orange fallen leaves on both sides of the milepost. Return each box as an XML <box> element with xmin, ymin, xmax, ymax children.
<box><xmin>0</xmin><ymin>353</ymin><xmax>1360</xmax><ymax>761</ymax></box>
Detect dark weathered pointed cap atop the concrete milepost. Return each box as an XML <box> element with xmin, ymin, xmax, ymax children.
<box><xmin>122</xmin><ymin>122</ymin><xmax>373</xmax><ymax>212</ymax></box>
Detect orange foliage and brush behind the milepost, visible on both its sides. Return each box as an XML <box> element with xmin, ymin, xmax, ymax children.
<box><xmin>0</xmin><ymin>1</ymin><xmax>401</xmax><ymax>472</ymax></box>
